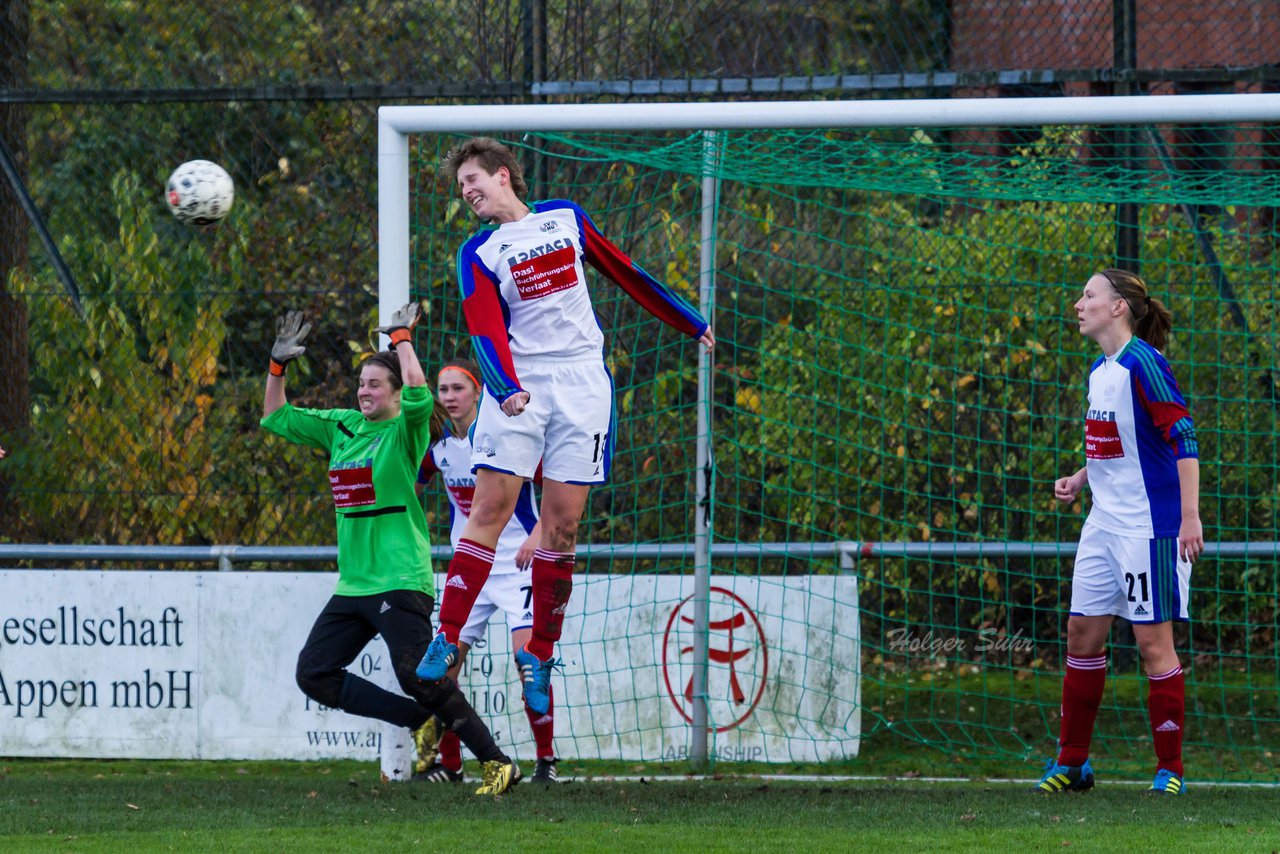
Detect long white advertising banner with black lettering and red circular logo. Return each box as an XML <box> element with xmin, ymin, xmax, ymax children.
<box><xmin>0</xmin><ymin>570</ymin><xmax>860</xmax><ymax>776</ymax></box>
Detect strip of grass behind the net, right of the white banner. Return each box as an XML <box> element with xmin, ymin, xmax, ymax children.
<box><xmin>849</xmin><ymin>666</ymin><xmax>1280</xmax><ymax>782</ymax></box>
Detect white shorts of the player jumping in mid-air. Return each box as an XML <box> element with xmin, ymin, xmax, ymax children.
<box><xmin>471</xmin><ymin>360</ymin><xmax>613</xmax><ymax>484</ymax></box>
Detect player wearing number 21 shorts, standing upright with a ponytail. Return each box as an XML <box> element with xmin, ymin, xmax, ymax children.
<box><xmin>1036</xmin><ymin>269</ymin><xmax>1204</xmax><ymax>795</ymax></box>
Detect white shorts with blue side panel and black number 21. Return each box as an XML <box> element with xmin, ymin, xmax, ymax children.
<box><xmin>1071</xmin><ymin>522</ymin><xmax>1192</xmax><ymax>624</ymax></box>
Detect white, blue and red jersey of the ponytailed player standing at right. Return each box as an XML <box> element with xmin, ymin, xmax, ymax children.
<box><xmin>1084</xmin><ymin>335</ymin><xmax>1198</xmax><ymax>538</ymax></box>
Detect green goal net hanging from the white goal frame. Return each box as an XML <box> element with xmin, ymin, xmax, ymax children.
<box><xmin>411</xmin><ymin>118</ymin><xmax>1280</xmax><ymax>781</ymax></box>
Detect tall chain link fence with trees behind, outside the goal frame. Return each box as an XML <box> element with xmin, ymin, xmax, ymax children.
<box><xmin>0</xmin><ymin>0</ymin><xmax>1280</xmax><ymax>544</ymax></box>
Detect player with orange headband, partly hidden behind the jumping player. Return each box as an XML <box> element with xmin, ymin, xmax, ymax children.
<box><xmin>417</xmin><ymin>359</ymin><xmax>557</xmax><ymax>784</ymax></box>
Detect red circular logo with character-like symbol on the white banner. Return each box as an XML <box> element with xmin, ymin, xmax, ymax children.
<box><xmin>662</xmin><ymin>588</ymin><xmax>769</xmax><ymax>732</ymax></box>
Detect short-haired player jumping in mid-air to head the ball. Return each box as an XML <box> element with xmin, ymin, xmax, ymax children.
<box><xmin>417</xmin><ymin>137</ymin><xmax>716</xmax><ymax>713</ymax></box>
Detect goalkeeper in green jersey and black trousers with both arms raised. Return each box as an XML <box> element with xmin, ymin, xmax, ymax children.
<box><xmin>261</xmin><ymin>302</ymin><xmax>520</xmax><ymax>795</ymax></box>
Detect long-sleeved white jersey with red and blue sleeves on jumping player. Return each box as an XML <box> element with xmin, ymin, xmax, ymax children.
<box><xmin>457</xmin><ymin>200</ymin><xmax>707</xmax><ymax>402</ymax></box>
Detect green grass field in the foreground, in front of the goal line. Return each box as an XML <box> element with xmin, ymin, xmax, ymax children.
<box><xmin>0</xmin><ymin>759</ymin><xmax>1280</xmax><ymax>853</ymax></box>
